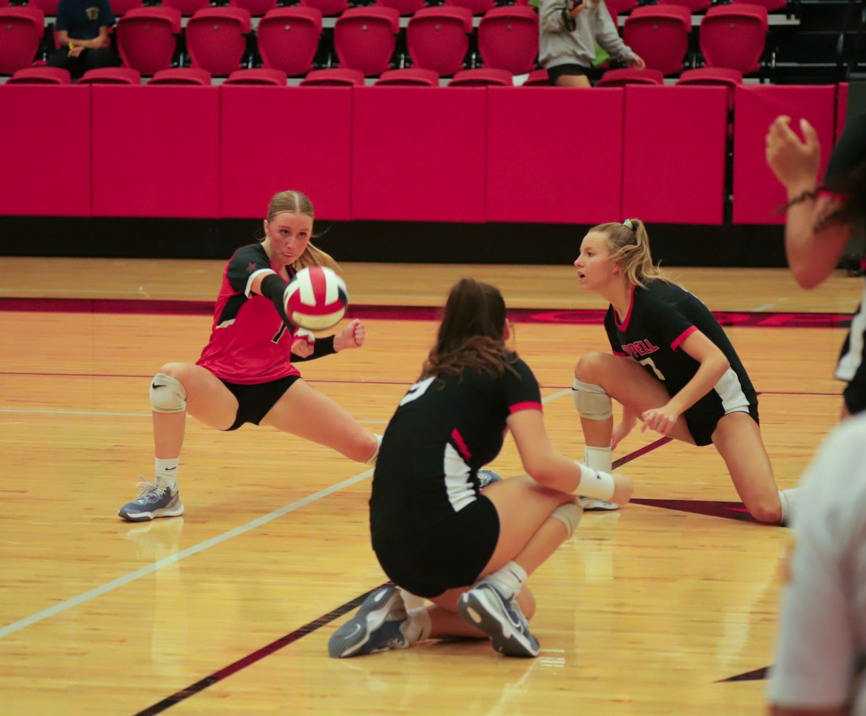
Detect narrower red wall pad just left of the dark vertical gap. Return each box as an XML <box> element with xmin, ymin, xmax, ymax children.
<box><xmin>622</xmin><ymin>85</ymin><xmax>728</xmax><ymax>224</ymax></box>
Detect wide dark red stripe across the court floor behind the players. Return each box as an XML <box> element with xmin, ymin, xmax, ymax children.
<box><xmin>0</xmin><ymin>298</ymin><xmax>851</xmax><ymax>328</ymax></box>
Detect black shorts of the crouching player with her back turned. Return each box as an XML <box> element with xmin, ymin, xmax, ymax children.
<box><xmin>373</xmin><ymin>495</ymin><xmax>499</xmax><ymax>599</ymax></box>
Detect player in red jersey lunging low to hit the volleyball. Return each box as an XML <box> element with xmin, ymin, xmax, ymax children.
<box><xmin>118</xmin><ymin>191</ymin><xmax>381</xmax><ymax>522</ymax></box>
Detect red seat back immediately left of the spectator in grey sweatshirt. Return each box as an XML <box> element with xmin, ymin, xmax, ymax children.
<box><xmin>478</xmin><ymin>5</ymin><xmax>538</xmax><ymax>75</ymax></box>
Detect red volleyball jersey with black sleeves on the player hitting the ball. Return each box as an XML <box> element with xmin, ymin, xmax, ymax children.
<box><xmin>196</xmin><ymin>244</ymin><xmax>300</xmax><ymax>385</ymax></box>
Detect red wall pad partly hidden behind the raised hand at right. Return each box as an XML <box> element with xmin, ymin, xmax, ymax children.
<box><xmin>734</xmin><ymin>85</ymin><xmax>836</xmax><ymax>224</ymax></box>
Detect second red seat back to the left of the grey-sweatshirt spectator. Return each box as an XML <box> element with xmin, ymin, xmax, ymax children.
<box><xmin>406</xmin><ymin>7</ymin><xmax>472</xmax><ymax>75</ymax></box>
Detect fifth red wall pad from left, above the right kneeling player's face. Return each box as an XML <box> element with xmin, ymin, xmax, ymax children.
<box><xmin>486</xmin><ymin>87</ymin><xmax>624</xmax><ymax>224</ymax></box>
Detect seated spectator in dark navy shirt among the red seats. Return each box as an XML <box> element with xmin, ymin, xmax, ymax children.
<box><xmin>47</xmin><ymin>0</ymin><xmax>120</xmax><ymax>79</ymax></box>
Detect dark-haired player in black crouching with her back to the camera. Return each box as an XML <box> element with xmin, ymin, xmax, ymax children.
<box><xmin>328</xmin><ymin>279</ymin><xmax>632</xmax><ymax>658</ymax></box>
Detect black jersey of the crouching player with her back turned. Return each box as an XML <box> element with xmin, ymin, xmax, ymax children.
<box><xmin>370</xmin><ymin>354</ymin><xmax>541</xmax><ymax>548</ymax></box>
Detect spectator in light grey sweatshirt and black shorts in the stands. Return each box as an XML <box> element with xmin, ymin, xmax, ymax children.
<box><xmin>538</xmin><ymin>0</ymin><xmax>646</xmax><ymax>87</ymax></box>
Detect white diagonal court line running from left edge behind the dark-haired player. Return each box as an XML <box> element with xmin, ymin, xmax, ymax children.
<box><xmin>0</xmin><ymin>389</ymin><xmax>571</xmax><ymax>639</ymax></box>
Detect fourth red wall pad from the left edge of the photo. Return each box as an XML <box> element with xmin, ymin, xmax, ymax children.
<box><xmin>352</xmin><ymin>87</ymin><xmax>487</xmax><ymax>222</ymax></box>
